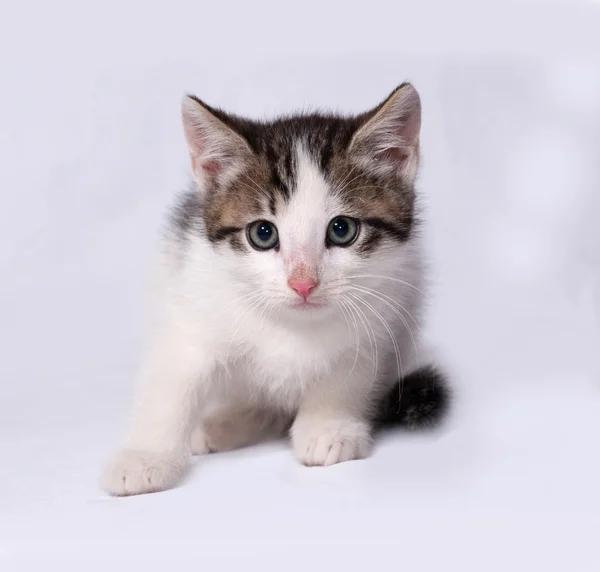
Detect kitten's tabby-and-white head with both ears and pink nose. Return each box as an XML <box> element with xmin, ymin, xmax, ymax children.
<box><xmin>183</xmin><ymin>84</ymin><xmax>421</xmax><ymax>316</ymax></box>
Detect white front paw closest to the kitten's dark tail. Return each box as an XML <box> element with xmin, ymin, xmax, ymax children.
<box><xmin>292</xmin><ymin>419</ymin><xmax>372</xmax><ymax>467</ymax></box>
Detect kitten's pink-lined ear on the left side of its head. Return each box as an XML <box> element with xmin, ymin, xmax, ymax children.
<box><xmin>181</xmin><ymin>95</ymin><xmax>252</xmax><ymax>190</ymax></box>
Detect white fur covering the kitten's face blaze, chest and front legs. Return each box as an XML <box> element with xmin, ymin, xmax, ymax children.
<box><xmin>102</xmin><ymin>145</ymin><xmax>421</xmax><ymax>495</ymax></box>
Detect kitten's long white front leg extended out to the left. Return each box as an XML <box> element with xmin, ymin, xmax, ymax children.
<box><xmin>101</xmin><ymin>339</ymin><xmax>213</xmax><ymax>496</ymax></box>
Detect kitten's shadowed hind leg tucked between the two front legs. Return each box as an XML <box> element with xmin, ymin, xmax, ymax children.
<box><xmin>191</xmin><ymin>404</ymin><xmax>292</xmax><ymax>455</ymax></box>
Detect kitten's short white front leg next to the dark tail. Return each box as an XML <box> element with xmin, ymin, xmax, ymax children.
<box><xmin>291</xmin><ymin>368</ymin><xmax>373</xmax><ymax>466</ymax></box>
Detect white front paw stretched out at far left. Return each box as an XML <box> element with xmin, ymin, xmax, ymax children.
<box><xmin>101</xmin><ymin>449</ymin><xmax>187</xmax><ymax>496</ymax></box>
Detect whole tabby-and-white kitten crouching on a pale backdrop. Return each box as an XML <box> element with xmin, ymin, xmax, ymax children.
<box><xmin>102</xmin><ymin>83</ymin><xmax>447</xmax><ymax>495</ymax></box>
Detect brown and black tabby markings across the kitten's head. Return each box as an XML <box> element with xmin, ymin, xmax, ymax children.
<box><xmin>171</xmin><ymin>84</ymin><xmax>415</xmax><ymax>256</ymax></box>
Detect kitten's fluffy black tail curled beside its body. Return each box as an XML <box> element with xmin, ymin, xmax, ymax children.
<box><xmin>376</xmin><ymin>366</ymin><xmax>452</xmax><ymax>429</ymax></box>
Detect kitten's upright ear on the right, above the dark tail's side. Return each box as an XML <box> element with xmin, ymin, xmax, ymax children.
<box><xmin>349</xmin><ymin>83</ymin><xmax>421</xmax><ymax>183</ymax></box>
